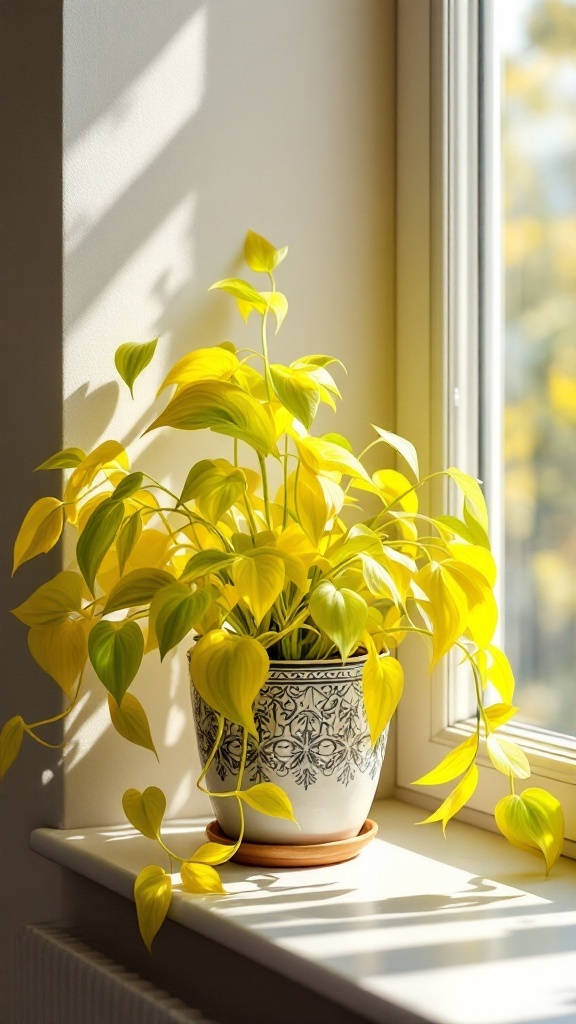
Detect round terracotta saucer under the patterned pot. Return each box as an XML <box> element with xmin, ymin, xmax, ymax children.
<box><xmin>206</xmin><ymin>818</ymin><xmax>378</xmax><ymax>867</ymax></box>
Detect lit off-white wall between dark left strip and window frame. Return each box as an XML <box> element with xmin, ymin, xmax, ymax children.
<box><xmin>64</xmin><ymin>0</ymin><xmax>395</xmax><ymax>826</ymax></box>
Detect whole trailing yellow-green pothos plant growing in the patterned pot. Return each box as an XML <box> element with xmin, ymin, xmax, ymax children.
<box><xmin>0</xmin><ymin>231</ymin><xmax>564</xmax><ymax>948</ymax></box>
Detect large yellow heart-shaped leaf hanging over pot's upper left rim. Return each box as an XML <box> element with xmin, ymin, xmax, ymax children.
<box><xmin>190</xmin><ymin>630</ymin><xmax>270</xmax><ymax>737</ymax></box>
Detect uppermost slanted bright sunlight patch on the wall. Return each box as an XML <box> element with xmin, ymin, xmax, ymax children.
<box><xmin>64</xmin><ymin>7</ymin><xmax>207</xmax><ymax>253</ymax></box>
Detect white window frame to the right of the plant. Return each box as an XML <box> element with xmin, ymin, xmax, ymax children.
<box><xmin>396</xmin><ymin>0</ymin><xmax>576</xmax><ymax>856</ymax></box>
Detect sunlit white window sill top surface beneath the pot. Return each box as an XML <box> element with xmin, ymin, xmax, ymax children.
<box><xmin>31</xmin><ymin>801</ymin><xmax>576</xmax><ymax>1024</ymax></box>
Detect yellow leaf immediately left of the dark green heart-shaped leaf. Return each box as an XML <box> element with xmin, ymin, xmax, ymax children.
<box><xmin>28</xmin><ymin>618</ymin><xmax>91</xmax><ymax>697</ymax></box>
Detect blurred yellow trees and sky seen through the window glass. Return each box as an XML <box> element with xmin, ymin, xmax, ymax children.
<box><xmin>498</xmin><ymin>0</ymin><xmax>576</xmax><ymax>736</ymax></box>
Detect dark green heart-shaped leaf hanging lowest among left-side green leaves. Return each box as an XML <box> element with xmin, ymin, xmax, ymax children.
<box><xmin>88</xmin><ymin>621</ymin><xmax>143</xmax><ymax>705</ymax></box>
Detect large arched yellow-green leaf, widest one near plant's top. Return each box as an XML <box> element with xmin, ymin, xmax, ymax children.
<box><xmin>145</xmin><ymin>381</ymin><xmax>276</xmax><ymax>456</ymax></box>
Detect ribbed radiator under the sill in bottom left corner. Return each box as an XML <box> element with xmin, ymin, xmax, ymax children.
<box><xmin>14</xmin><ymin>925</ymin><xmax>215</xmax><ymax>1024</ymax></box>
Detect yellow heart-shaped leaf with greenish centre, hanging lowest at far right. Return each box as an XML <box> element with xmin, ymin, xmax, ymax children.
<box><xmin>494</xmin><ymin>788</ymin><xmax>565</xmax><ymax>874</ymax></box>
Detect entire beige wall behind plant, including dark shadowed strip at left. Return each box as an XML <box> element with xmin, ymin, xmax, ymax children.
<box><xmin>0</xmin><ymin>0</ymin><xmax>395</xmax><ymax>1021</ymax></box>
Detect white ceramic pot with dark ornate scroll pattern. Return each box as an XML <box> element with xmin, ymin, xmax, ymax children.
<box><xmin>192</xmin><ymin>657</ymin><xmax>387</xmax><ymax>844</ymax></box>
